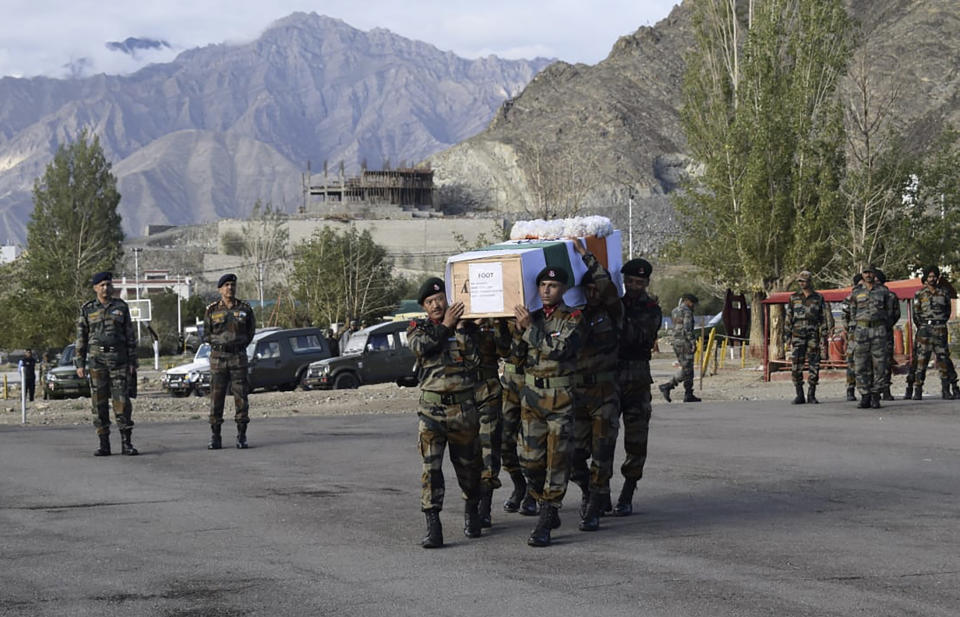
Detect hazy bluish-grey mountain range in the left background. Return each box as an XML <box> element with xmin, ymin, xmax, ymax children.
<box><xmin>0</xmin><ymin>13</ymin><xmax>550</xmax><ymax>241</ymax></box>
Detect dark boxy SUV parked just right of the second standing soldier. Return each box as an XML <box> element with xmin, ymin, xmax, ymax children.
<box><xmin>247</xmin><ymin>328</ymin><xmax>332</xmax><ymax>391</ymax></box>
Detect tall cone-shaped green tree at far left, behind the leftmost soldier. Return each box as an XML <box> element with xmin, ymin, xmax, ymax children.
<box><xmin>8</xmin><ymin>129</ymin><xmax>123</xmax><ymax>347</ymax></box>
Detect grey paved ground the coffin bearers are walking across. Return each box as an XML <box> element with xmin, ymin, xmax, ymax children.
<box><xmin>0</xmin><ymin>400</ymin><xmax>960</xmax><ymax>617</ymax></box>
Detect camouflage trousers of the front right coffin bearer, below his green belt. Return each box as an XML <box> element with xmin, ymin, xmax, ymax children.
<box><xmin>520</xmin><ymin>384</ymin><xmax>573</xmax><ymax>508</ymax></box>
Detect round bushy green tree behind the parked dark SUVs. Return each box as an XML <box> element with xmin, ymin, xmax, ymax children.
<box><xmin>290</xmin><ymin>227</ymin><xmax>403</xmax><ymax>325</ymax></box>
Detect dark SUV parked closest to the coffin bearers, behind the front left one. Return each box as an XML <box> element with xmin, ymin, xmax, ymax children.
<box><xmin>304</xmin><ymin>321</ymin><xmax>417</xmax><ymax>389</ymax></box>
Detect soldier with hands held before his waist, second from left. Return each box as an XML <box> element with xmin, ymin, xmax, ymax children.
<box><xmin>203</xmin><ymin>274</ymin><xmax>257</xmax><ymax>450</ymax></box>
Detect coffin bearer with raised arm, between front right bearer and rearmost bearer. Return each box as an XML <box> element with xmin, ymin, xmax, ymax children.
<box><xmin>570</xmin><ymin>240</ymin><xmax>623</xmax><ymax>531</ymax></box>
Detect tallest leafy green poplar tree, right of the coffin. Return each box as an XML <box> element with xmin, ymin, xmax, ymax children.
<box><xmin>676</xmin><ymin>0</ymin><xmax>850</xmax><ymax>354</ymax></box>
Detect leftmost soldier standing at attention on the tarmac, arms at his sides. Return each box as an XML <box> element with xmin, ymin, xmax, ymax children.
<box><xmin>74</xmin><ymin>272</ymin><xmax>139</xmax><ymax>456</ymax></box>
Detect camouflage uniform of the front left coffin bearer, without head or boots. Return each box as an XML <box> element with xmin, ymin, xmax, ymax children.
<box><xmin>407</xmin><ymin>319</ymin><xmax>482</xmax><ymax>512</ymax></box>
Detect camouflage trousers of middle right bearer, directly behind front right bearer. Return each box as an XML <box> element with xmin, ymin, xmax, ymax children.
<box><xmin>570</xmin><ymin>380</ymin><xmax>620</xmax><ymax>495</ymax></box>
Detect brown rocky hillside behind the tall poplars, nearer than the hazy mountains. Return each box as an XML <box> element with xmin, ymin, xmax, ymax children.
<box><xmin>428</xmin><ymin>0</ymin><xmax>960</xmax><ymax>253</ymax></box>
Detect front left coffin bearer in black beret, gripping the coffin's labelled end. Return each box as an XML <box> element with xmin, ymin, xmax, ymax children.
<box><xmin>407</xmin><ymin>278</ymin><xmax>482</xmax><ymax>548</ymax></box>
